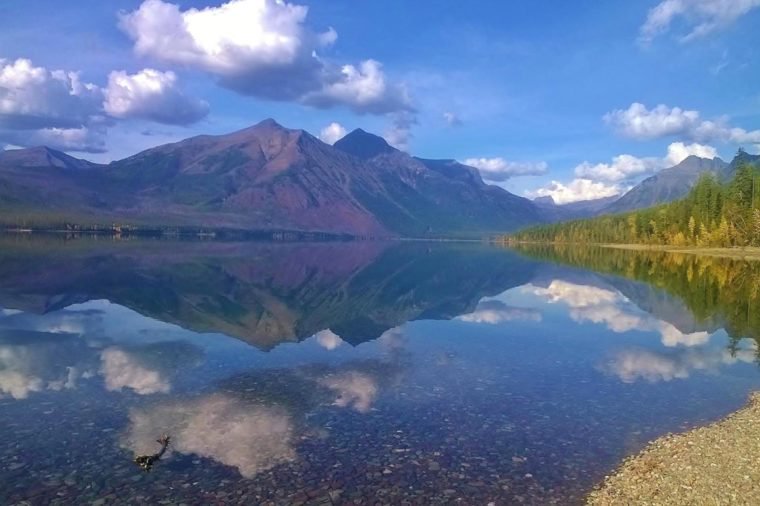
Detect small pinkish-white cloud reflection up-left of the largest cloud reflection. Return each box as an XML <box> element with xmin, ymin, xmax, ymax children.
<box><xmin>100</xmin><ymin>348</ymin><xmax>171</xmax><ymax>395</ymax></box>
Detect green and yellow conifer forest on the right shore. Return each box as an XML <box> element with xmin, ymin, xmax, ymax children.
<box><xmin>509</xmin><ymin>150</ymin><xmax>760</xmax><ymax>247</ymax></box>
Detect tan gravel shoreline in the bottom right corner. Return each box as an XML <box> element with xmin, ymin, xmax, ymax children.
<box><xmin>587</xmin><ymin>392</ymin><xmax>760</xmax><ymax>505</ymax></box>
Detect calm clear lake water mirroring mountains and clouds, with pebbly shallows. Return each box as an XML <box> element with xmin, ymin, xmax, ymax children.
<box><xmin>0</xmin><ymin>240</ymin><xmax>760</xmax><ymax>504</ymax></box>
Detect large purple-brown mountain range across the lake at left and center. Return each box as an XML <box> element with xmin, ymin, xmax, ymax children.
<box><xmin>0</xmin><ymin>119</ymin><xmax>543</xmax><ymax>236</ymax></box>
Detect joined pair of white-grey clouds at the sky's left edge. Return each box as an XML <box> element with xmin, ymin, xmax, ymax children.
<box><xmin>0</xmin><ymin>58</ymin><xmax>208</xmax><ymax>153</ymax></box>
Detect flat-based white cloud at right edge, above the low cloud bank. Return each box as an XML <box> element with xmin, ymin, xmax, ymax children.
<box><xmin>604</xmin><ymin>102</ymin><xmax>760</xmax><ymax>144</ymax></box>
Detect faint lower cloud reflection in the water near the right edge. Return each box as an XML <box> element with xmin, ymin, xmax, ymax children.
<box><xmin>601</xmin><ymin>343</ymin><xmax>756</xmax><ymax>383</ymax></box>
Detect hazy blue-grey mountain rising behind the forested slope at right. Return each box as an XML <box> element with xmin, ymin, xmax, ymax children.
<box><xmin>598</xmin><ymin>155</ymin><xmax>730</xmax><ymax>214</ymax></box>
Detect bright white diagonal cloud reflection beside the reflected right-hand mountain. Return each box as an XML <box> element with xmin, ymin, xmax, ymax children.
<box><xmin>531</xmin><ymin>279</ymin><xmax>710</xmax><ymax>347</ymax></box>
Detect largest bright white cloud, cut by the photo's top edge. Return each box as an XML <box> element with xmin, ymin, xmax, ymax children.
<box><xmin>119</xmin><ymin>0</ymin><xmax>328</xmax><ymax>99</ymax></box>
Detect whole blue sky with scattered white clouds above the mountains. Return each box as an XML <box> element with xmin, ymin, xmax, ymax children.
<box><xmin>0</xmin><ymin>0</ymin><xmax>760</xmax><ymax>203</ymax></box>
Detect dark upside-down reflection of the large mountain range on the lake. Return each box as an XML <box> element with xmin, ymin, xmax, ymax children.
<box><xmin>0</xmin><ymin>239</ymin><xmax>536</xmax><ymax>348</ymax></box>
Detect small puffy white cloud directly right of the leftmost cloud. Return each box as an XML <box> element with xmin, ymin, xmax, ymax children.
<box><xmin>103</xmin><ymin>69</ymin><xmax>209</xmax><ymax>125</ymax></box>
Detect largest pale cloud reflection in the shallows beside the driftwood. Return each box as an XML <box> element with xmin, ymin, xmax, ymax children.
<box><xmin>123</xmin><ymin>394</ymin><xmax>296</xmax><ymax>478</ymax></box>
